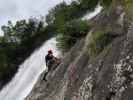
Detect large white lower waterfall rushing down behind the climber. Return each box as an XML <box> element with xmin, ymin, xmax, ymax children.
<box><xmin>0</xmin><ymin>38</ymin><xmax>59</xmax><ymax>100</ymax></box>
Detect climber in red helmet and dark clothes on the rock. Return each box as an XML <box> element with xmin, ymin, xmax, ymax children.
<box><xmin>43</xmin><ymin>49</ymin><xmax>60</xmax><ymax>80</ymax></box>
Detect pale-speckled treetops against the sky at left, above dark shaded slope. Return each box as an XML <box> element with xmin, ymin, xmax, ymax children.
<box><xmin>2</xmin><ymin>18</ymin><xmax>44</xmax><ymax>43</ymax></box>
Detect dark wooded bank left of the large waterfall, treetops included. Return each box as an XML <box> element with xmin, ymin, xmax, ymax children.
<box><xmin>0</xmin><ymin>18</ymin><xmax>51</xmax><ymax>82</ymax></box>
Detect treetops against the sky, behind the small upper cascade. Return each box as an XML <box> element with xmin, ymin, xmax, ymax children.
<box><xmin>46</xmin><ymin>0</ymin><xmax>99</xmax><ymax>25</ymax></box>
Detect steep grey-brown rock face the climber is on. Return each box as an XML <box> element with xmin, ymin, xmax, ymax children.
<box><xmin>26</xmin><ymin>0</ymin><xmax>133</xmax><ymax>100</ymax></box>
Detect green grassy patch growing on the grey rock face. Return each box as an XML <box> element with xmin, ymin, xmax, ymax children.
<box><xmin>88</xmin><ymin>32</ymin><xmax>114</xmax><ymax>57</ymax></box>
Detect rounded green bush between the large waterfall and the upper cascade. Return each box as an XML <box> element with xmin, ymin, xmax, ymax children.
<box><xmin>57</xmin><ymin>20</ymin><xmax>89</xmax><ymax>51</ymax></box>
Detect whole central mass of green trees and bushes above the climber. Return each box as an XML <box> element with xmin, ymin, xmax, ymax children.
<box><xmin>46</xmin><ymin>0</ymin><xmax>99</xmax><ymax>51</ymax></box>
